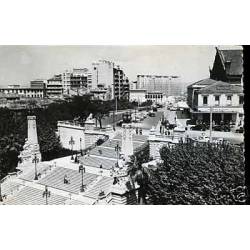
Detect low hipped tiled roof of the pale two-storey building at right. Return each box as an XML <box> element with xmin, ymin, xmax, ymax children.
<box><xmin>198</xmin><ymin>81</ymin><xmax>243</xmax><ymax>94</ymax></box>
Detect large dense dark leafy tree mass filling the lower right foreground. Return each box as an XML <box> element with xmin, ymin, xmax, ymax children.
<box><xmin>147</xmin><ymin>143</ymin><xmax>246</xmax><ymax>204</ymax></box>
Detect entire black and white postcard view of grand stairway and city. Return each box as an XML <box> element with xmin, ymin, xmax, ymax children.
<box><xmin>0</xmin><ymin>45</ymin><xmax>247</xmax><ymax>205</ymax></box>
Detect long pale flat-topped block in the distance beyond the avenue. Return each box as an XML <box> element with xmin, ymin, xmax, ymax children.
<box><xmin>136</xmin><ymin>75</ymin><xmax>183</xmax><ymax>96</ymax></box>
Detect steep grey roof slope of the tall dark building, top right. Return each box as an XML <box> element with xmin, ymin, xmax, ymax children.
<box><xmin>218</xmin><ymin>49</ymin><xmax>243</xmax><ymax>75</ymax></box>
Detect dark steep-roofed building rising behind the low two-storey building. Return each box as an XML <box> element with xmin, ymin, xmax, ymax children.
<box><xmin>210</xmin><ymin>46</ymin><xmax>243</xmax><ymax>85</ymax></box>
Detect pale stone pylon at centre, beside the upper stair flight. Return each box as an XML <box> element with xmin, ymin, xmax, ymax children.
<box><xmin>121</xmin><ymin>113</ymin><xmax>134</xmax><ymax>158</ymax></box>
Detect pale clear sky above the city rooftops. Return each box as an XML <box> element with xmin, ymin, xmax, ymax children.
<box><xmin>0</xmin><ymin>45</ymin><xmax>219</xmax><ymax>87</ymax></box>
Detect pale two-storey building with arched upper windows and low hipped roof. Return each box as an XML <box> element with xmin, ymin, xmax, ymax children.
<box><xmin>189</xmin><ymin>81</ymin><xmax>244</xmax><ymax>126</ymax></box>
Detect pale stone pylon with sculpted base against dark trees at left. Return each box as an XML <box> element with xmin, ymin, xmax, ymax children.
<box><xmin>19</xmin><ymin>116</ymin><xmax>42</xmax><ymax>165</ymax></box>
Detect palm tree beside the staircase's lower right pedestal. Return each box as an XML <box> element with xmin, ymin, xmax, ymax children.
<box><xmin>128</xmin><ymin>156</ymin><xmax>150</xmax><ymax>205</ymax></box>
